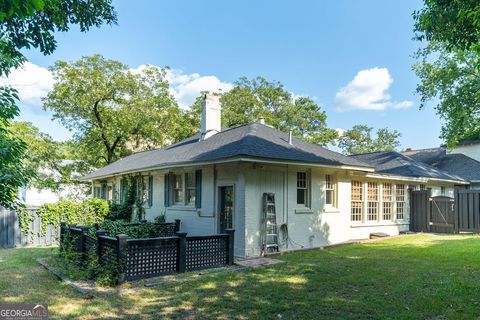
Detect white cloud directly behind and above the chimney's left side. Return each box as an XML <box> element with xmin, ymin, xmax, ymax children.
<box><xmin>167</xmin><ymin>69</ymin><xmax>233</xmax><ymax>108</ymax></box>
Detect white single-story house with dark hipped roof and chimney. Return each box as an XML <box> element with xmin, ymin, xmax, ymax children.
<box><xmin>83</xmin><ymin>95</ymin><xmax>467</xmax><ymax>257</ymax></box>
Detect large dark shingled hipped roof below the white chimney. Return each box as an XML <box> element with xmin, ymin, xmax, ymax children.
<box><xmin>83</xmin><ymin>123</ymin><xmax>373</xmax><ymax>180</ymax></box>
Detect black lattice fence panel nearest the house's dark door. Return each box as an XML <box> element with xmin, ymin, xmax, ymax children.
<box><xmin>186</xmin><ymin>235</ymin><xmax>229</xmax><ymax>271</ymax></box>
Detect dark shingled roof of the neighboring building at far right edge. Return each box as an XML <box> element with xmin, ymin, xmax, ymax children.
<box><xmin>403</xmin><ymin>148</ymin><xmax>480</xmax><ymax>181</ymax></box>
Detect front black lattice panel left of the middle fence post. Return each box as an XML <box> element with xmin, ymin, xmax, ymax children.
<box><xmin>126</xmin><ymin>237</ymin><xmax>179</xmax><ymax>280</ymax></box>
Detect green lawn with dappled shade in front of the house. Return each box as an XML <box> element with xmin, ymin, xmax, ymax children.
<box><xmin>0</xmin><ymin>234</ymin><xmax>480</xmax><ymax>319</ymax></box>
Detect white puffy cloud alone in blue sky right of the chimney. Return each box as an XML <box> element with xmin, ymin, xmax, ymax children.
<box><xmin>335</xmin><ymin>67</ymin><xmax>413</xmax><ymax>111</ymax></box>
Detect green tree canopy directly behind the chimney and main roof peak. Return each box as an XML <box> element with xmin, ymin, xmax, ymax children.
<box><xmin>184</xmin><ymin>77</ymin><xmax>338</xmax><ymax>145</ymax></box>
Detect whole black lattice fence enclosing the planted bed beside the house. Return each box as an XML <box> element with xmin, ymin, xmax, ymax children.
<box><xmin>60</xmin><ymin>223</ymin><xmax>234</xmax><ymax>282</ymax></box>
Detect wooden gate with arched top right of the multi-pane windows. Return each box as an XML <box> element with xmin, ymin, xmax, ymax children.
<box><xmin>410</xmin><ymin>190</ymin><xmax>456</xmax><ymax>233</ymax></box>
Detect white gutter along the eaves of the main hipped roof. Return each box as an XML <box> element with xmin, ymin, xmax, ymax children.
<box><xmin>80</xmin><ymin>157</ymin><xmax>375</xmax><ymax>181</ymax></box>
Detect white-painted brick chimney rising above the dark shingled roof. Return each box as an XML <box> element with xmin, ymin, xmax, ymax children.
<box><xmin>200</xmin><ymin>93</ymin><xmax>222</xmax><ymax>140</ymax></box>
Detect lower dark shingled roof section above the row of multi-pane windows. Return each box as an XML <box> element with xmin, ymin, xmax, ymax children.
<box><xmin>351</xmin><ymin>151</ymin><xmax>464</xmax><ymax>181</ymax></box>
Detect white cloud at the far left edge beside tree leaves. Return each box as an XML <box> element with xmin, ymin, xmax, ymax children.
<box><xmin>0</xmin><ymin>62</ymin><xmax>53</xmax><ymax>107</ymax></box>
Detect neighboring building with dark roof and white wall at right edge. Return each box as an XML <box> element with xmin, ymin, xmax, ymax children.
<box><xmin>402</xmin><ymin>143</ymin><xmax>480</xmax><ymax>189</ymax></box>
